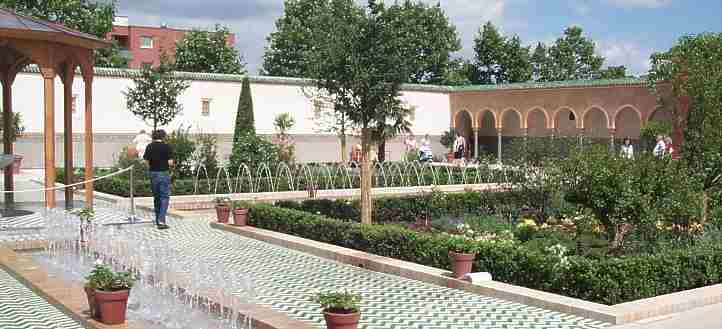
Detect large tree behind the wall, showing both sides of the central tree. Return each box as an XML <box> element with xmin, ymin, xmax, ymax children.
<box><xmin>262</xmin><ymin>0</ymin><xmax>461</xmax><ymax>83</ymax></box>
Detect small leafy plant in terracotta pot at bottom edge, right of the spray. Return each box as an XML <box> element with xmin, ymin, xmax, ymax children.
<box><xmin>313</xmin><ymin>291</ymin><xmax>361</xmax><ymax>329</ymax></box>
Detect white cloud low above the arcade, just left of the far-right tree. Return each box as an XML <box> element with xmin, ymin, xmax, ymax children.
<box><xmin>597</xmin><ymin>40</ymin><xmax>654</xmax><ymax>75</ymax></box>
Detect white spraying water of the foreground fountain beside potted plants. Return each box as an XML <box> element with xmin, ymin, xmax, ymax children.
<box><xmin>35</xmin><ymin>210</ymin><xmax>255</xmax><ymax>329</ymax></box>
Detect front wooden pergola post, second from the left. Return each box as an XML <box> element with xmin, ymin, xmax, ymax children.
<box><xmin>40</xmin><ymin>67</ymin><xmax>55</xmax><ymax>209</ymax></box>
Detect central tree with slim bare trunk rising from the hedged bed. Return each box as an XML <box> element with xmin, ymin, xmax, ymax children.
<box><xmin>311</xmin><ymin>0</ymin><xmax>415</xmax><ymax>223</ymax></box>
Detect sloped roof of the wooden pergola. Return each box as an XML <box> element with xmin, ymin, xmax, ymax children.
<box><xmin>0</xmin><ymin>8</ymin><xmax>110</xmax><ymax>49</ymax></box>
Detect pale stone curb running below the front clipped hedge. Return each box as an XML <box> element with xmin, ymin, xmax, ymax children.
<box><xmin>210</xmin><ymin>223</ymin><xmax>722</xmax><ymax>324</ymax></box>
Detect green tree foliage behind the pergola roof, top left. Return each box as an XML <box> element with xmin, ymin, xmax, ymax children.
<box><xmin>0</xmin><ymin>0</ymin><xmax>128</xmax><ymax>67</ymax></box>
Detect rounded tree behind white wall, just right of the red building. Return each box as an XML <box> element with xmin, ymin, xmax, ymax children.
<box><xmin>175</xmin><ymin>25</ymin><xmax>246</xmax><ymax>74</ymax></box>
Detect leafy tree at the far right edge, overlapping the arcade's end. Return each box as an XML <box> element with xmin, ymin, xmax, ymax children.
<box><xmin>649</xmin><ymin>33</ymin><xmax>722</xmax><ymax>217</ymax></box>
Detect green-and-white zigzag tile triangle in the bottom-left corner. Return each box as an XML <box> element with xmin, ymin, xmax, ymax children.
<box><xmin>0</xmin><ymin>269</ymin><xmax>85</xmax><ymax>329</ymax></box>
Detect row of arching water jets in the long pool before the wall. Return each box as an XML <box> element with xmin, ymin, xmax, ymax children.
<box><xmin>188</xmin><ymin>162</ymin><xmax>516</xmax><ymax>194</ymax></box>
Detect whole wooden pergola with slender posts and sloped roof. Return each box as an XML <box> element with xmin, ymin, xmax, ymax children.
<box><xmin>0</xmin><ymin>8</ymin><xmax>110</xmax><ymax>208</ymax></box>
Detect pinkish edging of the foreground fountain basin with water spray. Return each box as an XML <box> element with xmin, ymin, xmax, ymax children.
<box><xmin>0</xmin><ymin>245</ymin><xmax>316</xmax><ymax>329</ymax></box>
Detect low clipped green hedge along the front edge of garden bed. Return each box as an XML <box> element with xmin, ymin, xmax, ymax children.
<box><xmin>250</xmin><ymin>205</ymin><xmax>722</xmax><ymax>305</ymax></box>
